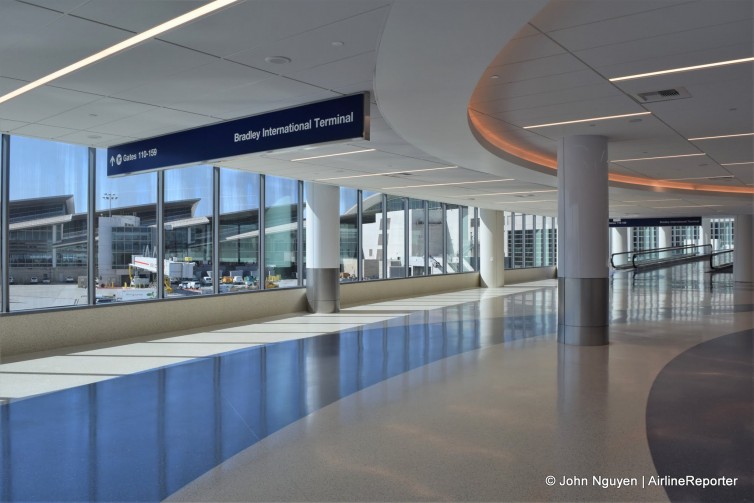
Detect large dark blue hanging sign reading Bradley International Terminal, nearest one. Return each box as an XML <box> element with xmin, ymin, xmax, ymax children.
<box><xmin>107</xmin><ymin>93</ymin><xmax>369</xmax><ymax>176</ymax></box>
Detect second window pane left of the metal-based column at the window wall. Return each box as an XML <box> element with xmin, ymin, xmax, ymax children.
<box><xmin>219</xmin><ymin>169</ymin><xmax>260</xmax><ymax>293</ymax></box>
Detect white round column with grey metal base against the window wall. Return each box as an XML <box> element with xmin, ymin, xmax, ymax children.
<box><xmin>306</xmin><ymin>182</ymin><xmax>340</xmax><ymax>313</ymax></box>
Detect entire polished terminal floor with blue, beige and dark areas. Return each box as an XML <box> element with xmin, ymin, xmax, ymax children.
<box><xmin>0</xmin><ymin>264</ymin><xmax>754</xmax><ymax>501</ymax></box>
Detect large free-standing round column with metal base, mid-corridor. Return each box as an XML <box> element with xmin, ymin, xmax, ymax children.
<box><xmin>558</xmin><ymin>135</ymin><xmax>609</xmax><ymax>346</ymax></box>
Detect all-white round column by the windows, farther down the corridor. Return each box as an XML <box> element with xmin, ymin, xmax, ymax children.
<box><xmin>479</xmin><ymin>208</ymin><xmax>505</xmax><ymax>288</ymax></box>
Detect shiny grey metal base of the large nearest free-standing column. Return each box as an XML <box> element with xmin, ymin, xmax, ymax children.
<box><xmin>558</xmin><ymin>278</ymin><xmax>610</xmax><ymax>346</ymax></box>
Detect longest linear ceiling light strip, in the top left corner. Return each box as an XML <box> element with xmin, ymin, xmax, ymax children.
<box><xmin>0</xmin><ymin>0</ymin><xmax>238</xmax><ymax>103</ymax></box>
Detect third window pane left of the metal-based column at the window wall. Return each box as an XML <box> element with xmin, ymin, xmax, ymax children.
<box><xmin>163</xmin><ymin>166</ymin><xmax>213</xmax><ymax>297</ymax></box>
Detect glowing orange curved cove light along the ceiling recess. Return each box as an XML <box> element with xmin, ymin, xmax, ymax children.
<box><xmin>467</xmin><ymin>108</ymin><xmax>754</xmax><ymax>195</ymax></box>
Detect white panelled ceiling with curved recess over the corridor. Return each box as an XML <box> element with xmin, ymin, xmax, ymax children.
<box><xmin>0</xmin><ymin>0</ymin><xmax>754</xmax><ymax>216</ymax></box>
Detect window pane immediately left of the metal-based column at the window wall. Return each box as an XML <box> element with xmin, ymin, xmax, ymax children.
<box><xmin>264</xmin><ymin>176</ymin><xmax>298</xmax><ymax>288</ymax></box>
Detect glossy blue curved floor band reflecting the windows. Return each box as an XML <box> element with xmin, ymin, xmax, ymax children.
<box><xmin>0</xmin><ymin>288</ymin><xmax>556</xmax><ymax>501</ymax></box>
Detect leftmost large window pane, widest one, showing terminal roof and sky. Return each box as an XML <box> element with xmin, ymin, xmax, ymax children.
<box><xmin>8</xmin><ymin>136</ymin><xmax>89</xmax><ymax>311</ymax></box>
